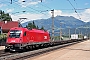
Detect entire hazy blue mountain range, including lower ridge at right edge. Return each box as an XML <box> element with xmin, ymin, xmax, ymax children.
<box><xmin>22</xmin><ymin>16</ymin><xmax>90</xmax><ymax>34</ymax></box>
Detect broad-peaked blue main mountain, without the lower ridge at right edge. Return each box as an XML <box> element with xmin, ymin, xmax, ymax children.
<box><xmin>22</xmin><ymin>16</ymin><xmax>85</xmax><ymax>29</ymax></box>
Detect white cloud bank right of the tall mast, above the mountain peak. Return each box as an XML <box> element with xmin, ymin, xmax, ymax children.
<box><xmin>49</xmin><ymin>9</ymin><xmax>90</xmax><ymax>22</ymax></box>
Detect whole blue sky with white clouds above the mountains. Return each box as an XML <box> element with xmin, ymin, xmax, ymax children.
<box><xmin>0</xmin><ymin>0</ymin><xmax>90</xmax><ymax>23</ymax></box>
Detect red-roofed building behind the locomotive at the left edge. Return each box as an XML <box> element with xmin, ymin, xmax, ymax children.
<box><xmin>0</xmin><ymin>21</ymin><xmax>21</xmax><ymax>34</ymax></box>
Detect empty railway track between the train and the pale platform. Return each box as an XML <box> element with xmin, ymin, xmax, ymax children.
<box><xmin>0</xmin><ymin>41</ymin><xmax>81</xmax><ymax>60</ymax></box>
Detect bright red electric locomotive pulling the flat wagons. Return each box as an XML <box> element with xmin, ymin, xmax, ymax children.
<box><xmin>5</xmin><ymin>27</ymin><xmax>50</xmax><ymax>51</ymax></box>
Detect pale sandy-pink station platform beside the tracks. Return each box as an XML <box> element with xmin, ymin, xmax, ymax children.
<box><xmin>26</xmin><ymin>40</ymin><xmax>90</xmax><ymax>60</ymax></box>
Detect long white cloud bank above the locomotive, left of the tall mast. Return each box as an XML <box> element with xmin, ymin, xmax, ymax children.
<box><xmin>11</xmin><ymin>13</ymin><xmax>46</xmax><ymax>23</ymax></box>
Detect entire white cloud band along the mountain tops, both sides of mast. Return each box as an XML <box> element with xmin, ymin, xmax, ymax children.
<box><xmin>11</xmin><ymin>9</ymin><xmax>90</xmax><ymax>23</ymax></box>
